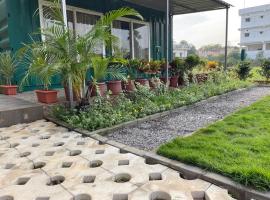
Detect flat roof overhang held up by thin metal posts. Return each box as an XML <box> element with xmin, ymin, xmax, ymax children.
<box><xmin>124</xmin><ymin>0</ymin><xmax>231</xmax><ymax>15</ymax></box>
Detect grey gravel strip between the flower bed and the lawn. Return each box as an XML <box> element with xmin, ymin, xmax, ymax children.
<box><xmin>107</xmin><ymin>87</ymin><xmax>270</xmax><ymax>151</ymax></box>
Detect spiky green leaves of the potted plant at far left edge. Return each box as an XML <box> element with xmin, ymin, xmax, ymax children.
<box><xmin>0</xmin><ymin>51</ymin><xmax>17</xmax><ymax>85</ymax></box>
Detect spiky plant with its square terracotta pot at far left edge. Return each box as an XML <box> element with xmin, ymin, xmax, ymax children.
<box><xmin>0</xmin><ymin>51</ymin><xmax>18</xmax><ymax>95</ymax></box>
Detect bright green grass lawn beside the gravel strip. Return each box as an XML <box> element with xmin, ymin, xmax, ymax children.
<box><xmin>158</xmin><ymin>97</ymin><xmax>270</xmax><ymax>191</ymax></box>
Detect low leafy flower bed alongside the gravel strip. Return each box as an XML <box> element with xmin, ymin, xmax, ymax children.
<box><xmin>53</xmin><ymin>73</ymin><xmax>250</xmax><ymax>131</ymax></box>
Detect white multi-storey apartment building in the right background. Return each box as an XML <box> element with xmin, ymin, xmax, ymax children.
<box><xmin>239</xmin><ymin>4</ymin><xmax>270</xmax><ymax>59</ymax></box>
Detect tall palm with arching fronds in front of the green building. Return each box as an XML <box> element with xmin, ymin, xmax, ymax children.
<box><xmin>34</xmin><ymin>1</ymin><xmax>143</xmax><ymax>103</ymax></box>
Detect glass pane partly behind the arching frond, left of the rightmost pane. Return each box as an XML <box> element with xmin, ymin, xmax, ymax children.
<box><xmin>112</xmin><ymin>21</ymin><xmax>132</xmax><ymax>59</ymax></box>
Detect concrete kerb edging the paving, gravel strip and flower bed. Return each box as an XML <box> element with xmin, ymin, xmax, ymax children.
<box><xmin>45</xmin><ymin>85</ymin><xmax>270</xmax><ymax>200</ymax></box>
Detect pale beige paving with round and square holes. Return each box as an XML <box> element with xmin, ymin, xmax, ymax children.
<box><xmin>0</xmin><ymin>120</ymin><xmax>231</xmax><ymax>200</ymax></box>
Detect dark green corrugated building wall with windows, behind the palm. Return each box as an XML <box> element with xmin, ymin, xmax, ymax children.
<box><xmin>0</xmin><ymin>0</ymin><xmax>172</xmax><ymax>90</ymax></box>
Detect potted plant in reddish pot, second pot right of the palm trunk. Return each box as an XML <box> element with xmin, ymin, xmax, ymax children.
<box><xmin>107</xmin><ymin>58</ymin><xmax>127</xmax><ymax>95</ymax></box>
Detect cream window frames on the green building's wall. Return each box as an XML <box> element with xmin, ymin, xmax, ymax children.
<box><xmin>38</xmin><ymin>0</ymin><xmax>151</xmax><ymax>61</ymax></box>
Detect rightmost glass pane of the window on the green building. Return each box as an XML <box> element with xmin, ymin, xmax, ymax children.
<box><xmin>133</xmin><ymin>23</ymin><xmax>150</xmax><ymax>60</ymax></box>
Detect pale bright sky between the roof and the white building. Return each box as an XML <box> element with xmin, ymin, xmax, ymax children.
<box><xmin>173</xmin><ymin>0</ymin><xmax>270</xmax><ymax>48</ymax></box>
